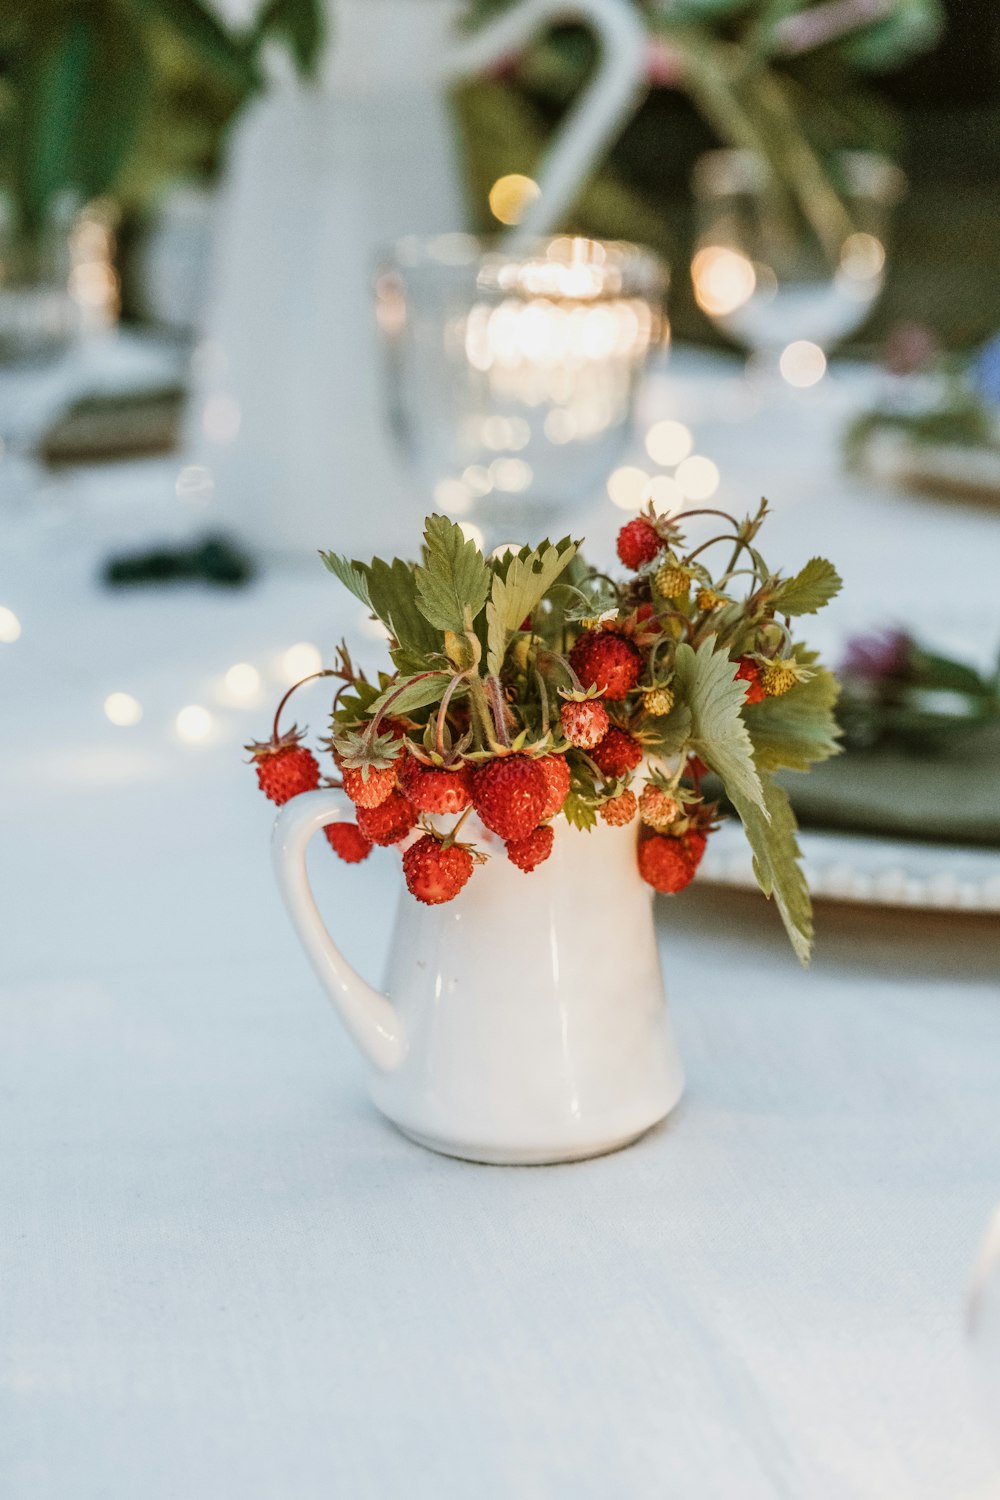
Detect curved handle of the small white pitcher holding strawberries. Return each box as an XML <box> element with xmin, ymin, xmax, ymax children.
<box><xmin>271</xmin><ymin>788</ymin><xmax>406</xmax><ymax>1073</ymax></box>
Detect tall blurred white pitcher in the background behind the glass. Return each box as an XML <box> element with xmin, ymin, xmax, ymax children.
<box><xmin>186</xmin><ymin>0</ymin><xmax>646</xmax><ymax>554</ymax></box>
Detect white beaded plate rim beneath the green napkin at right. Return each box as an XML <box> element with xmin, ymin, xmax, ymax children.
<box><xmin>699</xmin><ymin>819</ymin><xmax>1000</xmax><ymax>914</ymax></box>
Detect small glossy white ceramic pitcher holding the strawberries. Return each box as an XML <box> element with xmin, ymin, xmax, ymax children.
<box><xmin>273</xmin><ymin>791</ymin><xmax>684</xmax><ymax>1166</ymax></box>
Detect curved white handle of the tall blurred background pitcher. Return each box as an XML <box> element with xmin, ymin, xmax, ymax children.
<box><xmin>445</xmin><ymin>0</ymin><xmax>648</xmax><ymax>248</ymax></box>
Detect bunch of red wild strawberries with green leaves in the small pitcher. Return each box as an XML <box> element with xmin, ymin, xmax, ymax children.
<box><xmin>247</xmin><ymin>504</ymin><xmax>837</xmax><ymax>948</ymax></box>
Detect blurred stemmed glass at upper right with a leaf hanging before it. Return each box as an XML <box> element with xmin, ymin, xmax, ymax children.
<box><xmin>691</xmin><ymin>150</ymin><xmax>906</xmax><ymax>386</ymax></box>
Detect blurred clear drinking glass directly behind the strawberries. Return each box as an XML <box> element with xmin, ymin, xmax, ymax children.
<box><xmin>376</xmin><ymin>234</ymin><xmax>666</xmax><ymax>546</ymax></box>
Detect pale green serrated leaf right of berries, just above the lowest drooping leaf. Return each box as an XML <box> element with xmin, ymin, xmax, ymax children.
<box><xmin>673</xmin><ymin>636</ymin><xmax>766</xmax><ymax>818</ymax></box>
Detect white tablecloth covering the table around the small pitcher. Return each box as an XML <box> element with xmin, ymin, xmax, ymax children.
<box><xmin>0</xmin><ymin>343</ymin><xmax>1000</xmax><ymax>1500</ymax></box>
